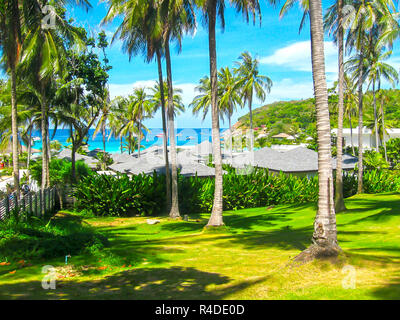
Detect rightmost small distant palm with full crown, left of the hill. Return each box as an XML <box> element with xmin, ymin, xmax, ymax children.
<box><xmin>235</xmin><ymin>51</ymin><xmax>272</xmax><ymax>151</ymax></box>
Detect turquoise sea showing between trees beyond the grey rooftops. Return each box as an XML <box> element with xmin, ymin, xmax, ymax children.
<box><xmin>32</xmin><ymin>128</ymin><xmax>226</xmax><ymax>153</ymax></box>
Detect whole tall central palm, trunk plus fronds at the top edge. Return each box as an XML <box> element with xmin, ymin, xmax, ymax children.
<box><xmin>196</xmin><ymin>0</ymin><xmax>261</xmax><ymax>227</ymax></box>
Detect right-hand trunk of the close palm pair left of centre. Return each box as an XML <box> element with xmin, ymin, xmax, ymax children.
<box><xmin>161</xmin><ymin>37</ymin><xmax>181</xmax><ymax>219</ymax></box>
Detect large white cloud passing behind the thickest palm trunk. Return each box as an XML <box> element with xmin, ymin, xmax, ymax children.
<box><xmin>260</xmin><ymin>41</ymin><xmax>338</xmax><ymax>73</ymax></box>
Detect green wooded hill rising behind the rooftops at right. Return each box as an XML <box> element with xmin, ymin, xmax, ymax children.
<box><xmin>235</xmin><ymin>89</ymin><xmax>400</xmax><ymax>135</ymax></box>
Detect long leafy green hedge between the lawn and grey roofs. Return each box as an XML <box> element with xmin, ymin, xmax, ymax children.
<box><xmin>75</xmin><ymin>166</ymin><xmax>400</xmax><ymax>216</ymax></box>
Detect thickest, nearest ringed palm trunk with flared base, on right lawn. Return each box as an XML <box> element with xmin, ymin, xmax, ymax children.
<box><xmin>296</xmin><ymin>0</ymin><xmax>341</xmax><ymax>261</ymax></box>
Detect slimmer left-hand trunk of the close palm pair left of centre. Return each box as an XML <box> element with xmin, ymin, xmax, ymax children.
<box><xmin>157</xmin><ymin>50</ymin><xmax>171</xmax><ymax>211</ymax></box>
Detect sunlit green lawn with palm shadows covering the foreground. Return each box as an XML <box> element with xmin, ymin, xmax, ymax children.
<box><xmin>0</xmin><ymin>194</ymin><xmax>400</xmax><ymax>299</ymax></box>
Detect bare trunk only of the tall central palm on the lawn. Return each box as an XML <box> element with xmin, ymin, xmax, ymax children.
<box><xmin>207</xmin><ymin>0</ymin><xmax>224</xmax><ymax>227</ymax></box>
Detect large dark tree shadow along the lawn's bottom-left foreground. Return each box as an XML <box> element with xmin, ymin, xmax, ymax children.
<box><xmin>0</xmin><ymin>267</ymin><xmax>266</xmax><ymax>300</ymax></box>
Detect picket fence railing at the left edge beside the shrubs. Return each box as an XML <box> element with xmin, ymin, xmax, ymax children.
<box><xmin>0</xmin><ymin>188</ymin><xmax>56</xmax><ymax>220</ymax></box>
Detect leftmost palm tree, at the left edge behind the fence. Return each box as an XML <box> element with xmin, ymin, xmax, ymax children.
<box><xmin>0</xmin><ymin>0</ymin><xmax>22</xmax><ymax>197</ymax></box>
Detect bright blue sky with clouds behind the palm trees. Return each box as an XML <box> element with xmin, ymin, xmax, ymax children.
<box><xmin>68</xmin><ymin>0</ymin><xmax>400</xmax><ymax>128</ymax></box>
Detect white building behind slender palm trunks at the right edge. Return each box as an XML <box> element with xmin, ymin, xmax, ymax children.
<box><xmin>332</xmin><ymin>127</ymin><xmax>400</xmax><ymax>149</ymax></box>
